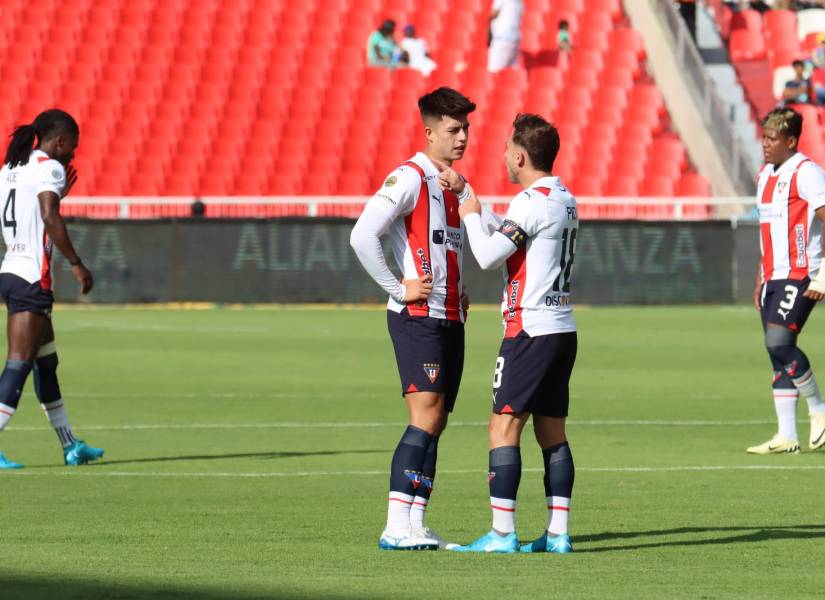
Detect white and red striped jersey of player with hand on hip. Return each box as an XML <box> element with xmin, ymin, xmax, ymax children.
<box><xmin>367</xmin><ymin>152</ymin><xmax>466</xmax><ymax>322</ymax></box>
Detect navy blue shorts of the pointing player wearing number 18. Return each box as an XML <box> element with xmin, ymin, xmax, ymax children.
<box><xmin>493</xmin><ymin>331</ymin><xmax>578</xmax><ymax>418</ymax></box>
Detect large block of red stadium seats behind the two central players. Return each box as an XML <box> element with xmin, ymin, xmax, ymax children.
<box><xmin>0</xmin><ymin>0</ymin><xmax>708</xmax><ymax>216</ymax></box>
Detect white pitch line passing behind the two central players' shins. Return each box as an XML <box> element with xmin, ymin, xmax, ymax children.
<box><xmin>7</xmin><ymin>463</ymin><xmax>825</xmax><ymax>479</ymax></box>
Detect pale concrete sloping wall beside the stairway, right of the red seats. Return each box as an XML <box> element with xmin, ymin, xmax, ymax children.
<box><xmin>624</xmin><ymin>0</ymin><xmax>744</xmax><ymax>196</ymax></box>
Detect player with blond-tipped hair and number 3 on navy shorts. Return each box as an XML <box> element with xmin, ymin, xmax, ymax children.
<box><xmin>747</xmin><ymin>108</ymin><xmax>825</xmax><ymax>454</ymax></box>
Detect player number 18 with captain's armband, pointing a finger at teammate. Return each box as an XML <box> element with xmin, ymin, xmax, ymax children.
<box><xmin>451</xmin><ymin>114</ymin><xmax>579</xmax><ymax>553</ymax></box>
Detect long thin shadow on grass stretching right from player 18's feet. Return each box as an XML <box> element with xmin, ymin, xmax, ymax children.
<box><xmin>575</xmin><ymin>524</ymin><xmax>825</xmax><ymax>553</ymax></box>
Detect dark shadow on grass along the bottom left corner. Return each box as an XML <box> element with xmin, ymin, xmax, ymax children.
<box><xmin>0</xmin><ymin>574</ymin><xmax>364</xmax><ymax>600</ymax></box>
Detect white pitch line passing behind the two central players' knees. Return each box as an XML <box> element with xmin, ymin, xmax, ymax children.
<box><xmin>6</xmin><ymin>420</ymin><xmax>774</xmax><ymax>432</ymax></box>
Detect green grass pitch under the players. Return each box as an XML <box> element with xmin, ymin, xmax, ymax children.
<box><xmin>0</xmin><ymin>306</ymin><xmax>825</xmax><ymax>600</ymax></box>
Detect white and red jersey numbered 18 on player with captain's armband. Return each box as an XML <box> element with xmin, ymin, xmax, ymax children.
<box><xmin>499</xmin><ymin>177</ymin><xmax>579</xmax><ymax>337</ymax></box>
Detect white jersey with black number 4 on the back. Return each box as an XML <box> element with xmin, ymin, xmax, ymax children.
<box><xmin>0</xmin><ymin>150</ymin><xmax>66</xmax><ymax>290</ymax></box>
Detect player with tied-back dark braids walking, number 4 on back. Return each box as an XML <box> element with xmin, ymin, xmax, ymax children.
<box><xmin>0</xmin><ymin>109</ymin><xmax>103</xmax><ymax>469</ymax></box>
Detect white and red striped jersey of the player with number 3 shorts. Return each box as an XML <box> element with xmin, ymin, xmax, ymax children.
<box><xmin>756</xmin><ymin>152</ymin><xmax>825</xmax><ymax>283</ymax></box>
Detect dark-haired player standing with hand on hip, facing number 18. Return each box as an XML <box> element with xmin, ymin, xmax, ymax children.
<box><xmin>350</xmin><ymin>87</ymin><xmax>498</xmax><ymax>550</ymax></box>
